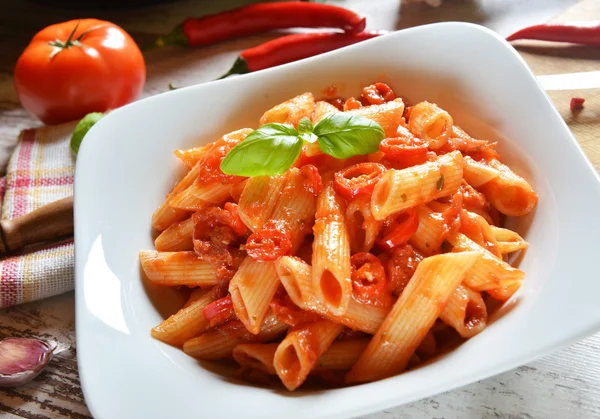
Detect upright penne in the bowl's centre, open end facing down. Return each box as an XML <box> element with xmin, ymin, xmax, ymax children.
<box><xmin>312</xmin><ymin>180</ymin><xmax>352</xmax><ymax>315</ymax></box>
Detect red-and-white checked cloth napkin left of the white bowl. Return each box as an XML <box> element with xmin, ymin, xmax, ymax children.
<box><xmin>0</xmin><ymin>123</ymin><xmax>76</xmax><ymax>308</ymax></box>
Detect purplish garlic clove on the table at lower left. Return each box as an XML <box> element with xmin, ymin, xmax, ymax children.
<box><xmin>0</xmin><ymin>338</ymin><xmax>56</xmax><ymax>387</ymax></box>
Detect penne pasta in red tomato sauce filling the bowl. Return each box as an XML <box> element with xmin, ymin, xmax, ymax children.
<box><xmin>139</xmin><ymin>82</ymin><xmax>538</xmax><ymax>391</ymax></box>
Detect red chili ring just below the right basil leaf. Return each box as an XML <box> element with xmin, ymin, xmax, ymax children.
<box><xmin>333</xmin><ymin>163</ymin><xmax>387</xmax><ymax>200</ymax></box>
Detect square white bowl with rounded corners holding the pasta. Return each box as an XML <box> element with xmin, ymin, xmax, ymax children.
<box><xmin>75</xmin><ymin>23</ymin><xmax>600</xmax><ymax>419</ymax></box>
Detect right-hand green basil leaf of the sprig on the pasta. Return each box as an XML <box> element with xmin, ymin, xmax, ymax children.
<box><xmin>314</xmin><ymin>112</ymin><xmax>385</xmax><ymax>159</ymax></box>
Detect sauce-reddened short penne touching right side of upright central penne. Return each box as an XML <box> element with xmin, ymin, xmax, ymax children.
<box><xmin>345</xmin><ymin>196</ymin><xmax>381</xmax><ymax>254</ymax></box>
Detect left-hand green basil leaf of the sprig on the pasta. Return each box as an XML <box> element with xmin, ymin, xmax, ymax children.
<box><xmin>221</xmin><ymin>123</ymin><xmax>302</xmax><ymax>176</ymax></box>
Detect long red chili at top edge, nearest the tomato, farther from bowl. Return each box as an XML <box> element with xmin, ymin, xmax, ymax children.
<box><xmin>154</xmin><ymin>1</ymin><xmax>366</xmax><ymax>47</ymax></box>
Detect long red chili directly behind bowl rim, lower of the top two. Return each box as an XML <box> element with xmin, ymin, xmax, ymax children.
<box><xmin>220</xmin><ymin>31</ymin><xmax>387</xmax><ymax>79</ymax></box>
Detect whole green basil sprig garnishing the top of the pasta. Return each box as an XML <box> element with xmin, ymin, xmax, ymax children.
<box><xmin>221</xmin><ymin>112</ymin><xmax>385</xmax><ymax>176</ymax></box>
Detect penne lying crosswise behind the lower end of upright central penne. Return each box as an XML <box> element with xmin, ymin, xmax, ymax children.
<box><xmin>275</xmin><ymin>256</ymin><xmax>390</xmax><ymax>334</ymax></box>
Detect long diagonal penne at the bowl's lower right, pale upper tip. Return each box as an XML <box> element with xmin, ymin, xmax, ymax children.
<box><xmin>346</xmin><ymin>252</ymin><xmax>481</xmax><ymax>383</ymax></box>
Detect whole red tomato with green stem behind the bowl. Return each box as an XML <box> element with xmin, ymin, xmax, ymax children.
<box><xmin>15</xmin><ymin>19</ymin><xmax>146</xmax><ymax>124</ymax></box>
